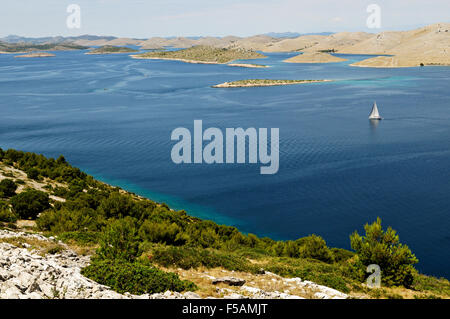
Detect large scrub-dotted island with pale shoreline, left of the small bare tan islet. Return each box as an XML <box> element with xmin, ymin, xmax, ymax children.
<box><xmin>131</xmin><ymin>45</ymin><xmax>266</xmax><ymax>67</ymax></box>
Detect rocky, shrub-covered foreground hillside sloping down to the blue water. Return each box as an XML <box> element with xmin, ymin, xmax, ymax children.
<box><xmin>0</xmin><ymin>149</ymin><xmax>450</xmax><ymax>299</ymax></box>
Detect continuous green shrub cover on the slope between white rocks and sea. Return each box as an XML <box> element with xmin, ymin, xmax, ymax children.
<box><xmin>0</xmin><ymin>149</ymin><xmax>450</xmax><ymax>298</ymax></box>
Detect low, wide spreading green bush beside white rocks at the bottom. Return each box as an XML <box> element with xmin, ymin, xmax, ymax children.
<box><xmin>81</xmin><ymin>259</ymin><xmax>197</xmax><ymax>295</ymax></box>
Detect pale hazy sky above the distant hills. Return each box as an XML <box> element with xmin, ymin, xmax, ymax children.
<box><xmin>0</xmin><ymin>0</ymin><xmax>450</xmax><ymax>38</ymax></box>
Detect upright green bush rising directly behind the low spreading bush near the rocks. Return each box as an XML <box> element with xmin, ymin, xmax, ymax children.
<box><xmin>97</xmin><ymin>217</ymin><xmax>141</xmax><ymax>261</ymax></box>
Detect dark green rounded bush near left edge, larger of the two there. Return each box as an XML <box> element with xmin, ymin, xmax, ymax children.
<box><xmin>11</xmin><ymin>189</ymin><xmax>50</xmax><ymax>219</ymax></box>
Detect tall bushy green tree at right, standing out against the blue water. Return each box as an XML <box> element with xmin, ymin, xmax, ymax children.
<box><xmin>350</xmin><ymin>218</ymin><xmax>418</xmax><ymax>288</ymax></box>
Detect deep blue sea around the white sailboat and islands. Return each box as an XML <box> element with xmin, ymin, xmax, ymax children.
<box><xmin>0</xmin><ymin>51</ymin><xmax>450</xmax><ymax>278</ymax></box>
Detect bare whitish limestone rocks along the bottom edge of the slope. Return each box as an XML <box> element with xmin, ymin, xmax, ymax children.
<box><xmin>0</xmin><ymin>230</ymin><xmax>348</xmax><ymax>299</ymax></box>
